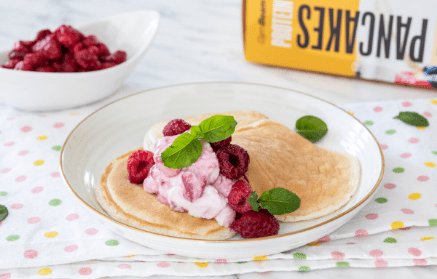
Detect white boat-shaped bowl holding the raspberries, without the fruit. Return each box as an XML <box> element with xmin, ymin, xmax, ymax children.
<box><xmin>0</xmin><ymin>11</ymin><xmax>160</xmax><ymax>111</ymax></box>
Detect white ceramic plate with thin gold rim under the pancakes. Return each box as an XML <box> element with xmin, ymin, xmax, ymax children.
<box><xmin>61</xmin><ymin>82</ymin><xmax>384</xmax><ymax>259</ymax></box>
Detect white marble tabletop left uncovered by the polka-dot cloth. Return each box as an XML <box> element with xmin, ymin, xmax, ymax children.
<box><xmin>0</xmin><ymin>0</ymin><xmax>437</xmax><ymax>279</ymax></box>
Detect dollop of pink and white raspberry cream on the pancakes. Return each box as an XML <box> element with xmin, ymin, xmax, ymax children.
<box><xmin>143</xmin><ymin>135</ymin><xmax>236</xmax><ymax>227</ymax></box>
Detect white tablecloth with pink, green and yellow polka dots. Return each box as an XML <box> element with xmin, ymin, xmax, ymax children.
<box><xmin>0</xmin><ymin>99</ymin><xmax>437</xmax><ymax>279</ymax></box>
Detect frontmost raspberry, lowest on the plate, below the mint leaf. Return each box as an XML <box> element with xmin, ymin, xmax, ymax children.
<box><xmin>230</xmin><ymin>209</ymin><xmax>279</xmax><ymax>238</ymax></box>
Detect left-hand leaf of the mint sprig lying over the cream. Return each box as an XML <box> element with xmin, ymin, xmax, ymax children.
<box><xmin>161</xmin><ymin>133</ymin><xmax>202</xmax><ymax>169</ymax></box>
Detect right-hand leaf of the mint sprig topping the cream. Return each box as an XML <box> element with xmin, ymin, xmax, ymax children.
<box><xmin>199</xmin><ymin>115</ymin><xmax>237</xmax><ymax>142</ymax></box>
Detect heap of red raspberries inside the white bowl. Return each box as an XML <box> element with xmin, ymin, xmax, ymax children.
<box><xmin>1</xmin><ymin>25</ymin><xmax>127</xmax><ymax>73</ymax></box>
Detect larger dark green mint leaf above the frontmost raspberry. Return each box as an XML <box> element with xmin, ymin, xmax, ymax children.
<box><xmin>258</xmin><ymin>188</ymin><xmax>300</xmax><ymax>215</ymax></box>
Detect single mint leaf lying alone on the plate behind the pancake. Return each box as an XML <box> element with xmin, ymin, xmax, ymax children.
<box><xmin>296</xmin><ymin>115</ymin><xmax>328</xmax><ymax>143</ymax></box>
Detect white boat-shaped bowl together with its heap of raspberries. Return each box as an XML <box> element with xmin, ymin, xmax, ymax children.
<box><xmin>0</xmin><ymin>10</ymin><xmax>160</xmax><ymax>111</ymax></box>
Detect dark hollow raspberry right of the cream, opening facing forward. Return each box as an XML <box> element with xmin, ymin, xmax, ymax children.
<box><xmin>216</xmin><ymin>144</ymin><xmax>250</xmax><ymax>179</ymax></box>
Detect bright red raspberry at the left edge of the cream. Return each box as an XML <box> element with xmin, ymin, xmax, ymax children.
<box><xmin>127</xmin><ymin>150</ymin><xmax>155</xmax><ymax>184</ymax></box>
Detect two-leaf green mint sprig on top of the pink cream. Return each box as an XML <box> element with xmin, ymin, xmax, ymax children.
<box><xmin>161</xmin><ymin>115</ymin><xmax>237</xmax><ymax>169</ymax></box>
